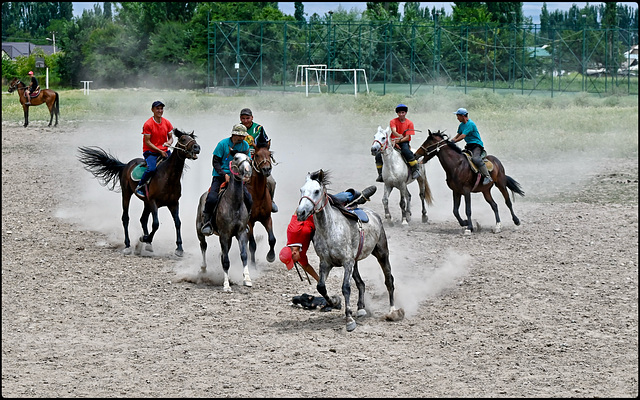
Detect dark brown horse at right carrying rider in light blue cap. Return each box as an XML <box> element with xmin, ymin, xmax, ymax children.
<box><xmin>415</xmin><ymin>130</ymin><xmax>524</xmax><ymax>235</ymax></box>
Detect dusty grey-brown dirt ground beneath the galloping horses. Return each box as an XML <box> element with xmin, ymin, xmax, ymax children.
<box><xmin>2</xmin><ymin>111</ymin><xmax>638</xmax><ymax>397</ymax></box>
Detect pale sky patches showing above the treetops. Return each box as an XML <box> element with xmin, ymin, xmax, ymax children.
<box><xmin>73</xmin><ymin>2</ymin><xmax>638</xmax><ymax>24</ymax></box>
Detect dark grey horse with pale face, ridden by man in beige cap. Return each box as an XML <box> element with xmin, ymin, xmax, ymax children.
<box><xmin>196</xmin><ymin>150</ymin><xmax>253</xmax><ymax>292</ymax></box>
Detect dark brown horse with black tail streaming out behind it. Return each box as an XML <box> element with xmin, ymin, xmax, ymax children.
<box><xmin>78</xmin><ymin>129</ymin><xmax>200</xmax><ymax>257</ymax></box>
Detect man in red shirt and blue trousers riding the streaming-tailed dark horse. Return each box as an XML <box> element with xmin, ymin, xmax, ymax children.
<box><xmin>135</xmin><ymin>101</ymin><xmax>173</xmax><ymax>197</ymax></box>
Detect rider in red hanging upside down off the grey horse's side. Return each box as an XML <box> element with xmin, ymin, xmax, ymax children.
<box><xmin>280</xmin><ymin>186</ymin><xmax>377</xmax><ymax>281</ymax></box>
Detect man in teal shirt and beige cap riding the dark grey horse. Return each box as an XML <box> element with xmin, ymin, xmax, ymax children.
<box><xmin>201</xmin><ymin>124</ymin><xmax>253</xmax><ymax>235</ymax></box>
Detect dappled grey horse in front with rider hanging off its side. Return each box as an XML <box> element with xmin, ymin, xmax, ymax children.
<box><xmin>296</xmin><ymin>169</ymin><xmax>404</xmax><ymax>332</ymax></box>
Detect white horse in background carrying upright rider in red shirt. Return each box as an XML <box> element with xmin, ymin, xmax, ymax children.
<box><xmin>371</xmin><ymin>126</ymin><xmax>433</xmax><ymax>226</ymax></box>
